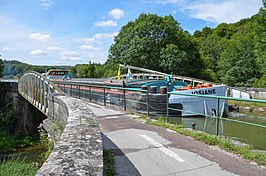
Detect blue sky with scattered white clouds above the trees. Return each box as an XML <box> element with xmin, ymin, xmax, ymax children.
<box><xmin>0</xmin><ymin>0</ymin><xmax>262</xmax><ymax>66</ymax></box>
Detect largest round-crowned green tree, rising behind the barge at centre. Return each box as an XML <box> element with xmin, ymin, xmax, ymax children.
<box><xmin>107</xmin><ymin>14</ymin><xmax>203</xmax><ymax>76</ymax></box>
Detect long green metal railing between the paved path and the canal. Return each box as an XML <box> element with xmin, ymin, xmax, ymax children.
<box><xmin>54</xmin><ymin>81</ymin><xmax>266</xmax><ymax>138</ymax></box>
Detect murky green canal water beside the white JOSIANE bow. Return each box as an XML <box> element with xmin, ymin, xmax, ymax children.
<box><xmin>170</xmin><ymin>112</ymin><xmax>266</xmax><ymax>151</ymax></box>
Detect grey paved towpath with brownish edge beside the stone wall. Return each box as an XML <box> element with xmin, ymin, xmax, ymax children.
<box><xmin>89</xmin><ymin>103</ymin><xmax>266</xmax><ymax>176</ymax></box>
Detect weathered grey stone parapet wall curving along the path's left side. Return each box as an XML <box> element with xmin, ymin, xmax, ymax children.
<box><xmin>36</xmin><ymin>94</ymin><xmax>103</xmax><ymax>176</ymax></box>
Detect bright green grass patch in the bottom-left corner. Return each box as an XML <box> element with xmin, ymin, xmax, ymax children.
<box><xmin>0</xmin><ymin>158</ymin><xmax>38</xmax><ymax>176</ymax></box>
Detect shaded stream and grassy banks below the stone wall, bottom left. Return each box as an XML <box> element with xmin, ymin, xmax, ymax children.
<box><xmin>0</xmin><ymin>130</ymin><xmax>47</xmax><ymax>176</ymax></box>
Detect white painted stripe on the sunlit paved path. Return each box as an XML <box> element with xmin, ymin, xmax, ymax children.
<box><xmin>140</xmin><ymin>134</ymin><xmax>185</xmax><ymax>162</ymax></box>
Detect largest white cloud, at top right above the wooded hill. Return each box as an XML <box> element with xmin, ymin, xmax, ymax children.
<box><xmin>186</xmin><ymin>0</ymin><xmax>262</xmax><ymax>24</ymax></box>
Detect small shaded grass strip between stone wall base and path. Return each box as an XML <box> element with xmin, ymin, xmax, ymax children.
<box><xmin>103</xmin><ymin>150</ymin><xmax>116</xmax><ymax>176</ymax></box>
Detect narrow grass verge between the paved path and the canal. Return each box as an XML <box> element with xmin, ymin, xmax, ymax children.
<box><xmin>140</xmin><ymin>115</ymin><xmax>266</xmax><ymax>166</ymax></box>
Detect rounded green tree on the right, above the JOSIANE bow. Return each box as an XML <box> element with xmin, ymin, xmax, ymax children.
<box><xmin>220</xmin><ymin>36</ymin><xmax>259</xmax><ymax>86</ymax></box>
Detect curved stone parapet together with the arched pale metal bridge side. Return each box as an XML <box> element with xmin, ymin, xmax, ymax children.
<box><xmin>18</xmin><ymin>72</ymin><xmax>103</xmax><ymax>175</ymax></box>
